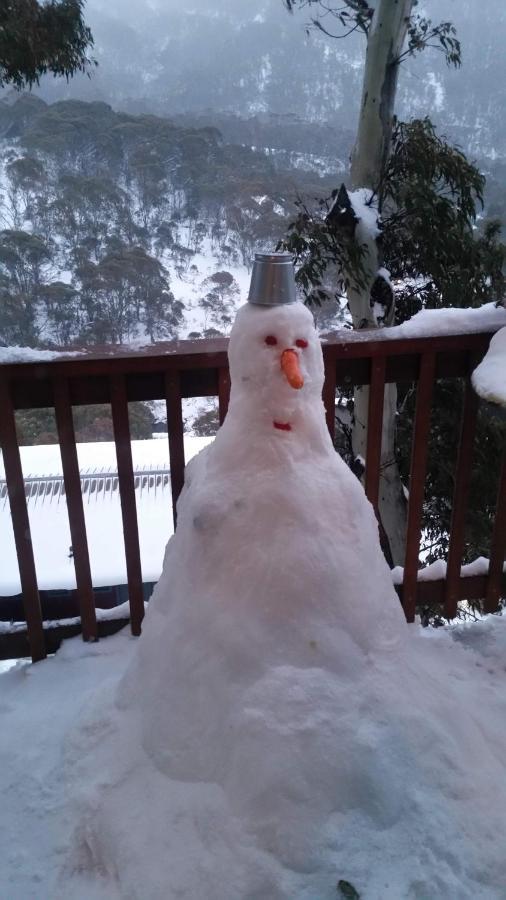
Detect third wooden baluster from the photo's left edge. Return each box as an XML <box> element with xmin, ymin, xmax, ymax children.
<box><xmin>110</xmin><ymin>375</ymin><xmax>144</xmax><ymax>635</ymax></box>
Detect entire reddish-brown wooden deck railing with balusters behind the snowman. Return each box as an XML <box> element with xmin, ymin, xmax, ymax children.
<box><xmin>0</xmin><ymin>330</ymin><xmax>506</xmax><ymax>660</ymax></box>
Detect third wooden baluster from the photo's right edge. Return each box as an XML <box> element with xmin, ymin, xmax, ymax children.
<box><xmin>402</xmin><ymin>351</ymin><xmax>436</xmax><ymax>622</ymax></box>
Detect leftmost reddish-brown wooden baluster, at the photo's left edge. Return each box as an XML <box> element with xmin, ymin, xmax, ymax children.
<box><xmin>0</xmin><ymin>378</ymin><xmax>46</xmax><ymax>662</ymax></box>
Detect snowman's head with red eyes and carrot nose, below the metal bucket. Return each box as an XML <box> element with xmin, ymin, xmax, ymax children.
<box><xmin>228</xmin><ymin>303</ymin><xmax>324</xmax><ymax>431</ymax></box>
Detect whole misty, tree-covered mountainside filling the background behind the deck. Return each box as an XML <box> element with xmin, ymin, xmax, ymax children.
<box><xmin>0</xmin><ymin>0</ymin><xmax>506</xmax><ymax>364</ymax></box>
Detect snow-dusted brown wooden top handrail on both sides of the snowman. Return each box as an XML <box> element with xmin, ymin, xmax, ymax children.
<box><xmin>0</xmin><ymin>329</ymin><xmax>494</xmax><ymax>409</ymax></box>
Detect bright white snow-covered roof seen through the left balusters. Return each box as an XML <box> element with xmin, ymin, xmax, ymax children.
<box><xmin>0</xmin><ymin>435</ymin><xmax>212</xmax><ymax>597</ymax></box>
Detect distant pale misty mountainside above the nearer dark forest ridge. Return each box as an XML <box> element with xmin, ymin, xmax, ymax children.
<box><xmin>30</xmin><ymin>0</ymin><xmax>506</xmax><ymax>157</ymax></box>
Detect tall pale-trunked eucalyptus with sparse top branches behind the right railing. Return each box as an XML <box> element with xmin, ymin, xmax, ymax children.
<box><xmin>285</xmin><ymin>0</ymin><xmax>468</xmax><ymax>563</ymax></box>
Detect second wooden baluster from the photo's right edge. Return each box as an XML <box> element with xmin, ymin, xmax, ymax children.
<box><xmin>444</xmin><ymin>379</ymin><xmax>478</xmax><ymax>619</ymax></box>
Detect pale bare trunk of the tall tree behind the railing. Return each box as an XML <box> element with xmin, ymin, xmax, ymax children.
<box><xmin>348</xmin><ymin>0</ymin><xmax>413</xmax><ymax>565</ymax></box>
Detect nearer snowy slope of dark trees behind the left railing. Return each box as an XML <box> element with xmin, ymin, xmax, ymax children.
<box><xmin>0</xmin><ymin>94</ymin><xmax>342</xmax><ymax>347</ymax></box>
